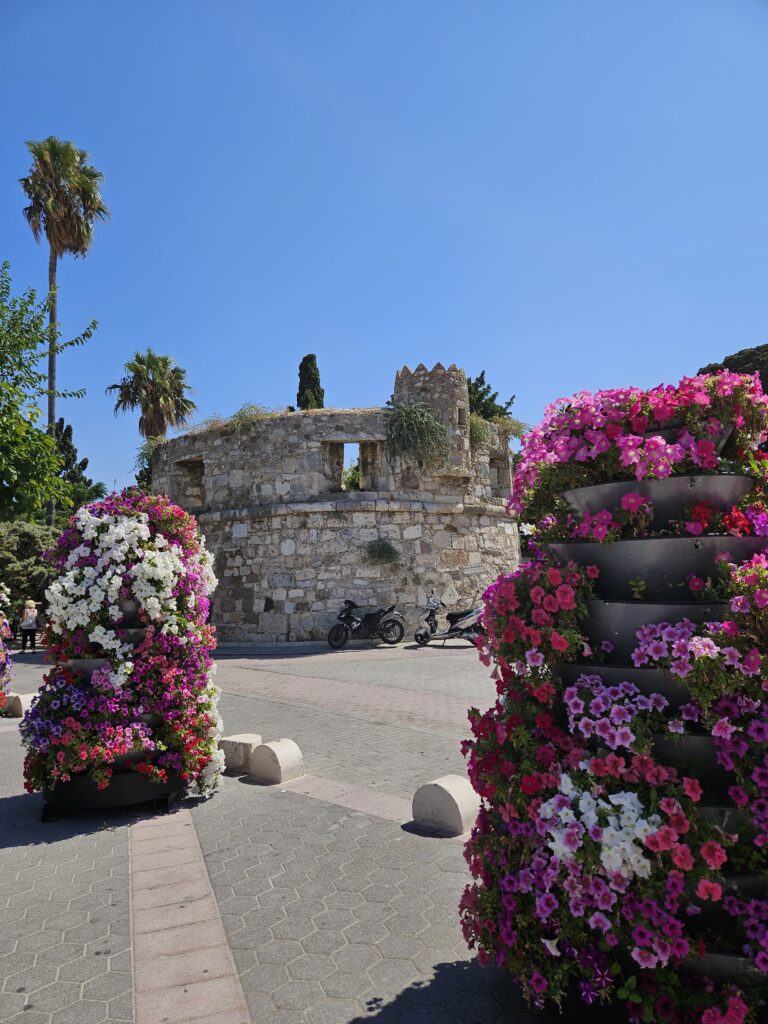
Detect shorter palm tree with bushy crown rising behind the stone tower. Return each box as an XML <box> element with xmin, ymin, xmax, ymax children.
<box><xmin>106</xmin><ymin>348</ymin><xmax>198</xmax><ymax>437</ymax></box>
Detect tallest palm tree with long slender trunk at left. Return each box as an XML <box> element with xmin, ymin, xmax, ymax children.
<box><xmin>19</xmin><ymin>135</ymin><xmax>110</xmax><ymax>524</ymax></box>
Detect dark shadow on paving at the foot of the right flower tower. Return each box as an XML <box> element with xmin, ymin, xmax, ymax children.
<box><xmin>349</xmin><ymin>961</ymin><xmax>542</xmax><ymax>1024</ymax></box>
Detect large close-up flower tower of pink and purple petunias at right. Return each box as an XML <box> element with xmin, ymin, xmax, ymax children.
<box><xmin>461</xmin><ymin>371</ymin><xmax>768</xmax><ymax>1024</ymax></box>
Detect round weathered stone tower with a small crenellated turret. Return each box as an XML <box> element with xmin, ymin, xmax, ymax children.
<box><xmin>153</xmin><ymin>362</ymin><xmax>518</xmax><ymax>641</ymax></box>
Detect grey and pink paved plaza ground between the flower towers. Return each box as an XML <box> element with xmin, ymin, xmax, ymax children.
<box><xmin>0</xmin><ymin>644</ymin><xmax>535</xmax><ymax>1024</ymax></box>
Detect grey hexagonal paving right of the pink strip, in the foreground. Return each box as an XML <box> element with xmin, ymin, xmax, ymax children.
<box><xmin>191</xmin><ymin>779</ymin><xmax>535</xmax><ymax>1024</ymax></box>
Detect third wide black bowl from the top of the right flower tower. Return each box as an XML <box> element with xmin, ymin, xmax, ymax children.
<box><xmin>584</xmin><ymin>601</ymin><xmax>728</xmax><ymax>665</ymax></box>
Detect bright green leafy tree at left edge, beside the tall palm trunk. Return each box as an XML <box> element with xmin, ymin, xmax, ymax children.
<box><xmin>0</xmin><ymin>263</ymin><xmax>96</xmax><ymax>520</ymax></box>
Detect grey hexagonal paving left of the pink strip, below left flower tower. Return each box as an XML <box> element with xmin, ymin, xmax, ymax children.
<box><xmin>0</xmin><ymin>732</ymin><xmax>133</xmax><ymax>1024</ymax></box>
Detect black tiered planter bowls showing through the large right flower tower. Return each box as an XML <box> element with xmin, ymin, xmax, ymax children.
<box><xmin>551</xmin><ymin>475</ymin><xmax>768</xmax><ymax>986</ymax></box>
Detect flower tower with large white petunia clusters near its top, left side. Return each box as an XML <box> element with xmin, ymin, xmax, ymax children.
<box><xmin>20</xmin><ymin>488</ymin><xmax>222</xmax><ymax>808</ymax></box>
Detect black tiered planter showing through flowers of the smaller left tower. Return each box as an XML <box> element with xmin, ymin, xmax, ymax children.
<box><xmin>43</xmin><ymin>601</ymin><xmax>186</xmax><ymax>820</ymax></box>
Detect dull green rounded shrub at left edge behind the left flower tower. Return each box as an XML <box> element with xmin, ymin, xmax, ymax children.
<box><xmin>0</xmin><ymin>524</ymin><xmax>58</xmax><ymax>616</ymax></box>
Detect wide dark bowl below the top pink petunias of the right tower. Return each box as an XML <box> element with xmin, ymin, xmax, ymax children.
<box><xmin>563</xmin><ymin>473</ymin><xmax>754</xmax><ymax>529</ymax></box>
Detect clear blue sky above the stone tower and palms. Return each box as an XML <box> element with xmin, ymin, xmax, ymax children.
<box><xmin>0</xmin><ymin>0</ymin><xmax>768</xmax><ymax>486</ymax></box>
